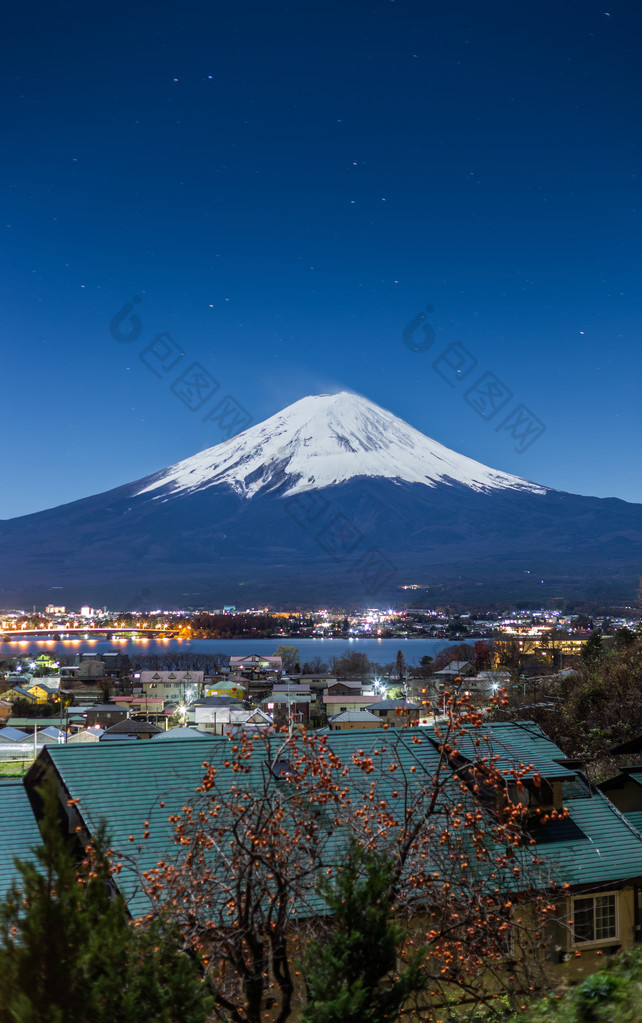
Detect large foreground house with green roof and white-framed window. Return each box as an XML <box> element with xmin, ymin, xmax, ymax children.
<box><xmin>25</xmin><ymin>721</ymin><xmax>642</xmax><ymax>976</ymax></box>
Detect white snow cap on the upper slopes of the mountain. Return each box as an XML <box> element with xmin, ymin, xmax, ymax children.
<box><xmin>138</xmin><ymin>391</ymin><xmax>546</xmax><ymax>498</ymax></box>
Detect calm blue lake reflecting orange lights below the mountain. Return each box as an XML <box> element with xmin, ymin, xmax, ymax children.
<box><xmin>0</xmin><ymin>637</ymin><xmax>462</xmax><ymax>664</ymax></box>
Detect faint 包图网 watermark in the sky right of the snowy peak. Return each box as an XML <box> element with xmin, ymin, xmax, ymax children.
<box><xmin>402</xmin><ymin>306</ymin><xmax>546</xmax><ymax>454</ymax></box>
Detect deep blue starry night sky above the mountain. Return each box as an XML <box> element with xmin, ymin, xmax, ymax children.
<box><xmin>0</xmin><ymin>0</ymin><xmax>642</xmax><ymax>518</ymax></box>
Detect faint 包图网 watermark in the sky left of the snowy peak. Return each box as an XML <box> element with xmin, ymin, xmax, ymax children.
<box><xmin>109</xmin><ymin>295</ymin><xmax>254</xmax><ymax>440</ymax></box>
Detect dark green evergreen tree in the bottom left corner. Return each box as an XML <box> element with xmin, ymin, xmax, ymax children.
<box><xmin>0</xmin><ymin>786</ymin><xmax>208</xmax><ymax>1023</ymax></box>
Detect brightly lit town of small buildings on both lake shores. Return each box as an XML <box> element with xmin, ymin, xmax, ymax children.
<box><xmin>0</xmin><ymin>606</ymin><xmax>639</xmax><ymax>760</ymax></box>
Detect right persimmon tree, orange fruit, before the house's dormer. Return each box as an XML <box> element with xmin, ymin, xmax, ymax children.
<box><xmin>339</xmin><ymin>694</ymin><xmax>566</xmax><ymax>1019</ymax></box>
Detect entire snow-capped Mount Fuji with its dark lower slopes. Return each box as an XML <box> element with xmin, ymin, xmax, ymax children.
<box><xmin>0</xmin><ymin>392</ymin><xmax>642</xmax><ymax>608</ymax></box>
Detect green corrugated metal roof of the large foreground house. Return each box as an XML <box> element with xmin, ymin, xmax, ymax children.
<box><xmin>27</xmin><ymin>722</ymin><xmax>642</xmax><ymax>915</ymax></box>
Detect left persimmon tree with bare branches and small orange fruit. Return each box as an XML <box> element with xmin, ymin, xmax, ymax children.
<box><xmin>144</xmin><ymin>732</ymin><xmax>346</xmax><ymax>1023</ymax></box>
